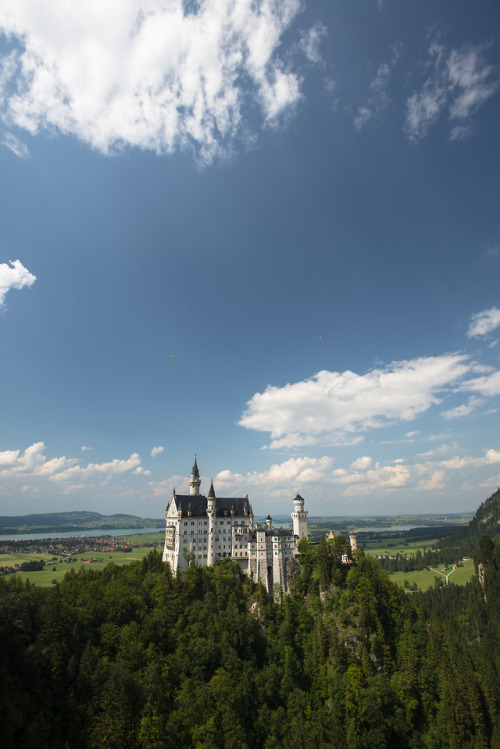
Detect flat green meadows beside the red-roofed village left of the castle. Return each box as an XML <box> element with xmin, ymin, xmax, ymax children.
<box><xmin>0</xmin><ymin>533</ymin><xmax>163</xmax><ymax>586</ymax></box>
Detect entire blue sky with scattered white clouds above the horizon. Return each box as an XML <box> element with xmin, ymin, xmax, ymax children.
<box><xmin>0</xmin><ymin>0</ymin><xmax>500</xmax><ymax>517</ymax></box>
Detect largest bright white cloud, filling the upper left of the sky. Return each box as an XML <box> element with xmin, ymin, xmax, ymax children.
<box><xmin>0</xmin><ymin>0</ymin><xmax>308</xmax><ymax>162</ymax></box>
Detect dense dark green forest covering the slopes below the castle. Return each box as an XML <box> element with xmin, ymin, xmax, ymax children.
<box><xmin>0</xmin><ymin>496</ymin><xmax>500</xmax><ymax>749</ymax></box>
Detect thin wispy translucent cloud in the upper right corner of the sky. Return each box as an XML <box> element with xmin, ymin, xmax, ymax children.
<box><xmin>405</xmin><ymin>42</ymin><xmax>499</xmax><ymax>141</ymax></box>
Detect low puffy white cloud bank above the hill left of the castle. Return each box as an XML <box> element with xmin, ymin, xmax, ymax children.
<box><xmin>0</xmin><ymin>442</ymin><xmax>149</xmax><ymax>488</ymax></box>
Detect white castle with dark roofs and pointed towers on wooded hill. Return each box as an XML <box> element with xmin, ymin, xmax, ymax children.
<box><xmin>163</xmin><ymin>458</ymin><xmax>308</xmax><ymax>592</ymax></box>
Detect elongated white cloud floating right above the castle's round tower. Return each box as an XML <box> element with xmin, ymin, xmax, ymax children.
<box><xmin>239</xmin><ymin>353</ymin><xmax>476</xmax><ymax>448</ymax></box>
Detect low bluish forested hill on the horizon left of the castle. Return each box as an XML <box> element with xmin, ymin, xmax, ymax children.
<box><xmin>0</xmin><ymin>511</ymin><xmax>163</xmax><ymax>533</ymax></box>
